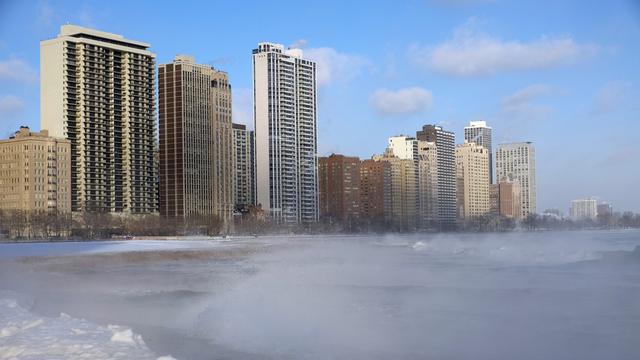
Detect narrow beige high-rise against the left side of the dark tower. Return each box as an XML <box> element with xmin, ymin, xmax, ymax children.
<box><xmin>418</xmin><ymin>140</ymin><xmax>438</xmax><ymax>229</ymax></box>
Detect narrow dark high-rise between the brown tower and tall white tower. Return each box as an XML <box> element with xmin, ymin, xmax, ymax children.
<box><xmin>233</xmin><ymin>124</ymin><xmax>256</xmax><ymax>212</ymax></box>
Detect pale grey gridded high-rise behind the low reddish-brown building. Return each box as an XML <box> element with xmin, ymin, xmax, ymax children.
<box><xmin>496</xmin><ymin>142</ymin><xmax>536</xmax><ymax>218</ymax></box>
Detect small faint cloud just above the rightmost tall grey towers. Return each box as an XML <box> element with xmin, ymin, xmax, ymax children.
<box><xmin>501</xmin><ymin>84</ymin><xmax>551</xmax><ymax>120</ymax></box>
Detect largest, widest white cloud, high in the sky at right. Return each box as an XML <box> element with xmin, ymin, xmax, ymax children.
<box><xmin>411</xmin><ymin>19</ymin><xmax>597</xmax><ymax>77</ymax></box>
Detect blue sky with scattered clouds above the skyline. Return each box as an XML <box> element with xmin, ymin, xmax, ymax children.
<box><xmin>0</xmin><ymin>0</ymin><xmax>640</xmax><ymax>212</ymax></box>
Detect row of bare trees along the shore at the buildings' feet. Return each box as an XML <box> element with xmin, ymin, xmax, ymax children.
<box><xmin>0</xmin><ymin>209</ymin><xmax>640</xmax><ymax>240</ymax></box>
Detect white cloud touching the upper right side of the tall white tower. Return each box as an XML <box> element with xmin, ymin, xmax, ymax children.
<box><xmin>304</xmin><ymin>47</ymin><xmax>369</xmax><ymax>86</ymax></box>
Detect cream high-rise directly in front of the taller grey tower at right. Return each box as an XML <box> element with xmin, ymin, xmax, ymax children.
<box><xmin>456</xmin><ymin>142</ymin><xmax>490</xmax><ymax>219</ymax></box>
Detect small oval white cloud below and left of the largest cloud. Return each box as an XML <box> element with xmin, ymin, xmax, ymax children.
<box><xmin>369</xmin><ymin>86</ymin><xmax>433</xmax><ymax>115</ymax></box>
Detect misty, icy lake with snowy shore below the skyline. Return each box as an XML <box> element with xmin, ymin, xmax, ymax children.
<box><xmin>0</xmin><ymin>231</ymin><xmax>640</xmax><ymax>360</ymax></box>
